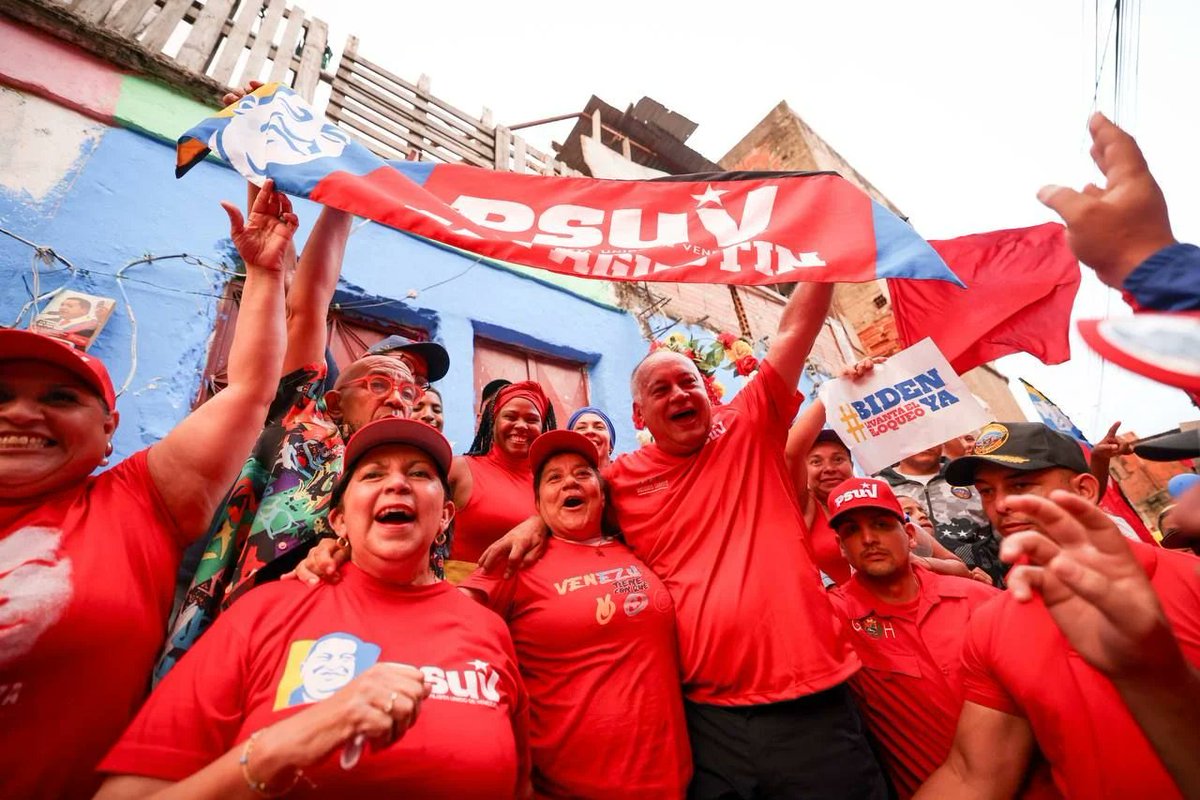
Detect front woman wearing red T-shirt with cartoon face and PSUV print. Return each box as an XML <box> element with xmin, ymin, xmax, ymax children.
<box><xmin>97</xmin><ymin>419</ymin><xmax>528</xmax><ymax>800</ymax></box>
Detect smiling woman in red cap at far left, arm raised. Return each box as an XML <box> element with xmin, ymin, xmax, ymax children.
<box><xmin>0</xmin><ymin>182</ymin><xmax>296</xmax><ymax>798</ymax></box>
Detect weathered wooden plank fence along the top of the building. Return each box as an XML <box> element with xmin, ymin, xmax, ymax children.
<box><xmin>16</xmin><ymin>0</ymin><xmax>576</xmax><ymax>175</ymax></box>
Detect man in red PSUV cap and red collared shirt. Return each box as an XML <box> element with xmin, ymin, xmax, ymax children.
<box><xmin>829</xmin><ymin>477</ymin><xmax>1000</xmax><ymax>798</ymax></box>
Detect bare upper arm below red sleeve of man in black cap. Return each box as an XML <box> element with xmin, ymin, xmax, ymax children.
<box><xmin>913</xmin><ymin>700</ymin><xmax>1033</xmax><ymax>800</ymax></box>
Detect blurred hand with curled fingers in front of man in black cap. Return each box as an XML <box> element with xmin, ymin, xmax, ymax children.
<box><xmin>1001</xmin><ymin>491</ymin><xmax>1183</xmax><ymax>679</ymax></box>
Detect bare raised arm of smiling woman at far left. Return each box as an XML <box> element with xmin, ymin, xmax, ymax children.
<box><xmin>148</xmin><ymin>181</ymin><xmax>296</xmax><ymax>539</ymax></box>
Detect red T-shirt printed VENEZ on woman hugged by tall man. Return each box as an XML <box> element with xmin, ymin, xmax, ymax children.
<box><xmin>462</xmin><ymin>536</ymin><xmax>691</xmax><ymax>798</ymax></box>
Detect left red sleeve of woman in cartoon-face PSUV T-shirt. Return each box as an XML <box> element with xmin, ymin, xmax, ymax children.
<box><xmin>97</xmin><ymin>601</ymin><xmax>250</xmax><ymax>781</ymax></box>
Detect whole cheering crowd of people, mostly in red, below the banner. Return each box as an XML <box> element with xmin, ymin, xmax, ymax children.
<box><xmin>0</xmin><ymin>109</ymin><xmax>1200</xmax><ymax>800</ymax></box>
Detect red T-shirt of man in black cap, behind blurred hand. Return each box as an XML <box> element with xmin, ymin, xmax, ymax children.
<box><xmin>962</xmin><ymin>542</ymin><xmax>1200</xmax><ymax>800</ymax></box>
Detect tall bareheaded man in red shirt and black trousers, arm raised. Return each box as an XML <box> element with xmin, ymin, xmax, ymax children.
<box><xmin>606</xmin><ymin>284</ymin><xmax>886</xmax><ymax>799</ymax></box>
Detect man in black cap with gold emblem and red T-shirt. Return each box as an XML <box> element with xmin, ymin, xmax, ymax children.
<box><xmin>918</xmin><ymin>422</ymin><xmax>1200</xmax><ymax>800</ymax></box>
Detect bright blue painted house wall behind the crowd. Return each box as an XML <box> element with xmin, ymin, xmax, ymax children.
<box><xmin>0</xmin><ymin>128</ymin><xmax>652</xmax><ymax>457</ymax></box>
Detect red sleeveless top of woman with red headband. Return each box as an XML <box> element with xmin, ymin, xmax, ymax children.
<box><xmin>450</xmin><ymin>445</ymin><xmax>538</xmax><ymax>563</ymax></box>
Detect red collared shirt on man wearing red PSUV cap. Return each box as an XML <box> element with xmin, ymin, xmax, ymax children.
<box><xmin>830</xmin><ymin>567</ymin><xmax>1000</xmax><ymax>798</ymax></box>
